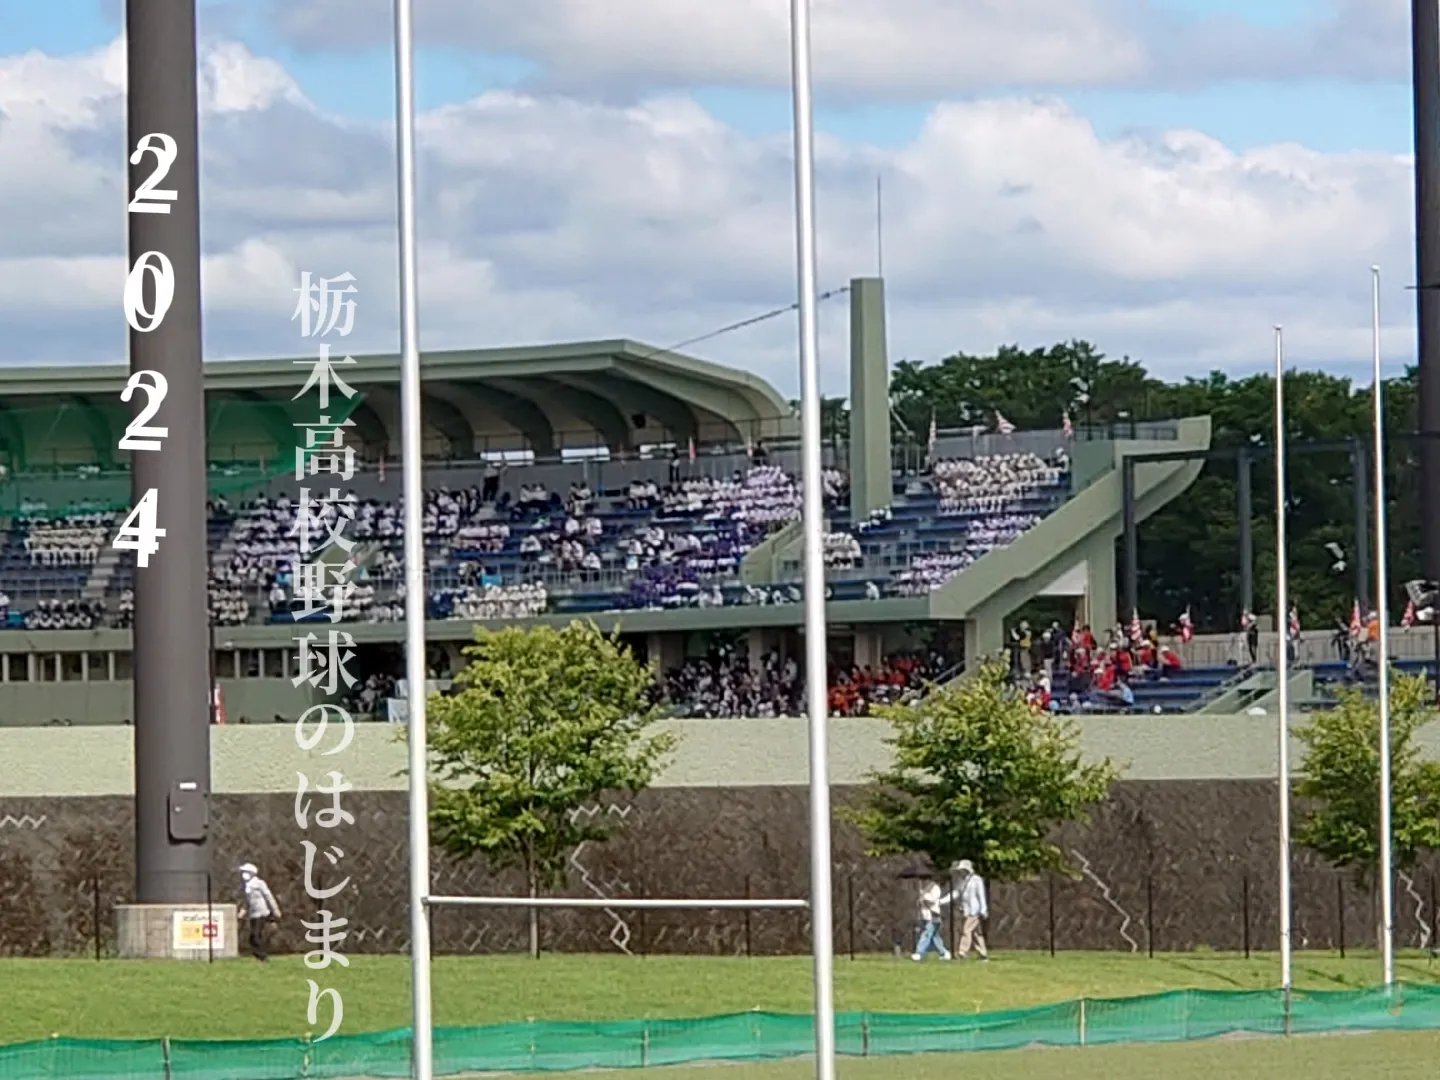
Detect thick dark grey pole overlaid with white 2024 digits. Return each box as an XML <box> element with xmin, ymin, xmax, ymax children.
<box><xmin>125</xmin><ymin>0</ymin><xmax>210</xmax><ymax>904</ymax></box>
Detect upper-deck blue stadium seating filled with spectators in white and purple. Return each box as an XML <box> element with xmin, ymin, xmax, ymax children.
<box><xmin>0</xmin><ymin>454</ymin><xmax>1068</xmax><ymax>626</ymax></box>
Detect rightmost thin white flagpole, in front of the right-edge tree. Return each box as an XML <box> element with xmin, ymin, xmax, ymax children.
<box><xmin>1369</xmin><ymin>266</ymin><xmax>1395</xmax><ymax>986</ymax></box>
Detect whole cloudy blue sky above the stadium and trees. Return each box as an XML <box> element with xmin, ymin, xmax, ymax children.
<box><xmin>0</xmin><ymin>0</ymin><xmax>1414</xmax><ymax>389</ymax></box>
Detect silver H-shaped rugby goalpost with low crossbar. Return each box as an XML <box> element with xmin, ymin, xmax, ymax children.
<box><xmin>395</xmin><ymin>0</ymin><xmax>835</xmax><ymax>1080</ymax></box>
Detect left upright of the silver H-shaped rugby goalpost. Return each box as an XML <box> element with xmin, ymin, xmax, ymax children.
<box><xmin>395</xmin><ymin>0</ymin><xmax>435</xmax><ymax>1080</ymax></box>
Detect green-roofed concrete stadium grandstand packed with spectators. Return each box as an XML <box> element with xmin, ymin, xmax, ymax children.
<box><xmin>0</xmin><ymin>279</ymin><xmax>1232</xmax><ymax>724</ymax></box>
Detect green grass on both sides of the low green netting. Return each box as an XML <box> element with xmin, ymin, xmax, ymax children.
<box><xmin>0</xmin><ymin>952</ymin><xmax>1440</xmax><ymax>1080</ymax></box>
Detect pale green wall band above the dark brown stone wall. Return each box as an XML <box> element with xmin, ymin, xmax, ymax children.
<box><xmin>0</xmin><ymin>716</ymin><xmax>1440</xmax><ymax>798</ymax></box>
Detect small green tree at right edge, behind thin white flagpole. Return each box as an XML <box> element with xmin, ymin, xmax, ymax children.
<box><xmin>1295</xmin><ymin>675</ymin><xmax>1440</xmax><ymax>933</ymax></box>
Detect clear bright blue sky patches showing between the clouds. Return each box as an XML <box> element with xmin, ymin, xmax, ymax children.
<box><xmin>0</xmin><ymin>0</ymin><xmax>1413</xmax><ymax>153</ymax></box>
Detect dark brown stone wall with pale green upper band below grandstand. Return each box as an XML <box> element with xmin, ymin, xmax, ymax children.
<box><xmin>0</xmin><ymin>716</ymin><xmax>1440</xmax><ymax>955</ymax></box>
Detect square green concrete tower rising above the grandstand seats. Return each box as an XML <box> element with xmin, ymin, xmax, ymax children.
<box><xmin>850</xmin><ymin>278</ymin><xmax>891</xmax><ymax>524</ymax></box>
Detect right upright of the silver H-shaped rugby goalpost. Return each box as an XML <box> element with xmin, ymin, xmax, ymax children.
<box><xmin>791</xmin><ymin>0</ymin><xmax>835</xmax><ymax>1080</ymax></box>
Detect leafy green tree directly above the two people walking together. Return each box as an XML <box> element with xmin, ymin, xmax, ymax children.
<box><xmin>848</xmin><ymin>664</ymin><xmax>1119</xmax><ymax>881</ymax></box>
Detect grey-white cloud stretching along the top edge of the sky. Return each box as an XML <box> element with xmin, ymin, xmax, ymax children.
<box><xmin>272</xmin><ymin>0</ymin><xmax>1410</xmax><ymax>102</ymax></box>
